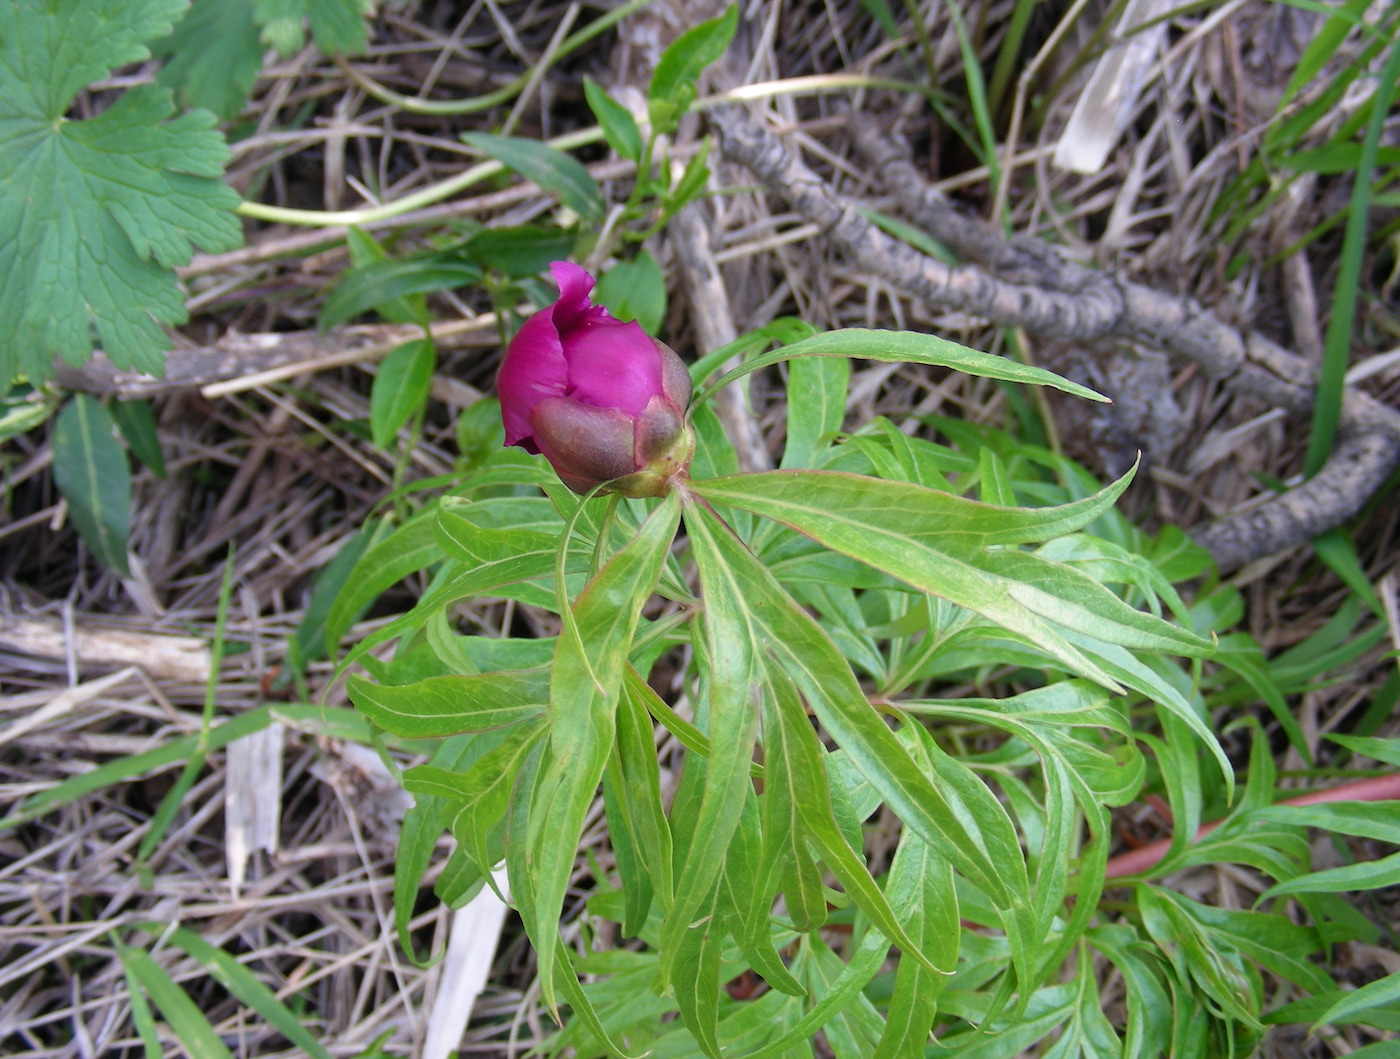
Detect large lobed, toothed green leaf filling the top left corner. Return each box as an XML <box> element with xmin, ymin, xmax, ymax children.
<box><xmin>0</xmin><ymin>0</ymin><xmax>242</xmax><ymax>385</ymax></box>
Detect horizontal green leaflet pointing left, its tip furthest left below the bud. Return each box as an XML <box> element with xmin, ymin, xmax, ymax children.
<box><xmin>349</xmin><ymin>668</ymin><xmax>549</xmax><ymax>740</ymax></box>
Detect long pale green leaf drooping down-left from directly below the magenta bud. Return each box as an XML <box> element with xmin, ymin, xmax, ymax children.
<box><xmin>523</xmin><ymin>494</ymin><xmax>680</xmax><ymax>1007</ymax></box>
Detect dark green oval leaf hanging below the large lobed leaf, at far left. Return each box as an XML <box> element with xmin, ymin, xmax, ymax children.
<box><xmin>50</xmin><ymin>394</ymin><xmax>132</xmax><ymax>576</ymax></box>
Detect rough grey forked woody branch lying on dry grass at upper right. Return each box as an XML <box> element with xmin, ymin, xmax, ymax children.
<box><xmin>711</xmin><ymin>108</ymin><xmax>1400</xmax><ymax>572</ymax></box>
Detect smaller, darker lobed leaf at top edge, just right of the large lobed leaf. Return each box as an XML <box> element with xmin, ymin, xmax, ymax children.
<box><xmin>151</xmin><ymin>0</ymin><xmax>263</xmax><ymax>122</ymax></box>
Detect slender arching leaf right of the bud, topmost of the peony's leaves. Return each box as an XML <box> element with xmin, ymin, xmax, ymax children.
<box><xmin>697</xmin><ymin>328</ymin><xmax>1107</xmax><ymax>402</ymax></box>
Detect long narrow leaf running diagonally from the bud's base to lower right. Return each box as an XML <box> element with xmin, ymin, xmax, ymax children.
<box><xmin>676</xmin><ymin>501</ymin><xmax>1030</xmax><ymax>958</ymax></box>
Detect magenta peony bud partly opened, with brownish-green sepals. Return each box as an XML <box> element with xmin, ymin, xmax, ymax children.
<box><xmin>496</xmin><ymin>261</ymin><xmax>694</xmax><ymax>496</ymax></box>
